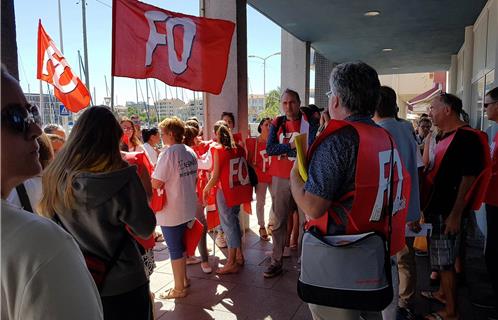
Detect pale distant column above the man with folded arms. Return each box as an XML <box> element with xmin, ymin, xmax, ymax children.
<box><xmin>281</xmin><ymin>29</ymin><xmax>310</xmax><ymax>105</ymax></box>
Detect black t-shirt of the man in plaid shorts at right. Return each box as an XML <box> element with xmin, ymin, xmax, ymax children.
<box><xmin>424</xmin><ymin>126</ymin><xmax>484</xmax><ymax>221</ymax></box>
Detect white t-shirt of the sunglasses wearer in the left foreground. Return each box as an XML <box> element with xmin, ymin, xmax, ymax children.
<box><xmin>1</xmin><ymin>200</ymin><xmax>103</xmax><ymax>320</ymax></box>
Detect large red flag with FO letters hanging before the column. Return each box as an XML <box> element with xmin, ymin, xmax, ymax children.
<box><xmin>112</xmin><ymin>0</ymin><xmax>235</xmax><ymax>94</ymax></box>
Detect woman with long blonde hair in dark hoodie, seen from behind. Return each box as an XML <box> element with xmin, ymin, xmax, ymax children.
<box><xmin>39</xmin><ymin>106</ymin><xmax>156</xmax><ymax>319</ymax></box>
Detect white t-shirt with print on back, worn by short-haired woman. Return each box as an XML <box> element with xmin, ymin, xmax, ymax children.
<box><xmin>152</xmin><ymin>144</ymin><xmax>197</xmax><ymax>227</ymax></box>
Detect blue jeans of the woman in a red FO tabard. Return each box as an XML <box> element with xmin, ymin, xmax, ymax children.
<box><xmin>216</xmin><ymin>189</ymin><xmax>242</xmax><ymax>248</ymax></box>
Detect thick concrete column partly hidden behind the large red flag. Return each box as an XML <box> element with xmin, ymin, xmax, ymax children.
<box><xmin>200</xmin><ymin>0</ymin><xmax>248</xmax><ymax>138</ymax></box>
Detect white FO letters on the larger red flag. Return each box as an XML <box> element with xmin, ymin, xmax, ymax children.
<box><xmin>145</xmin><ymin>11</ymin><xmax>196</xmax><ymax>75</ymax></box>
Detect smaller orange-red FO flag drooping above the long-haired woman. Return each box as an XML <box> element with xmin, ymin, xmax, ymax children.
<box><xmin>36</xmin><ymin>20</ymin><xmax>90</xmax><ymax>112</ymax></box>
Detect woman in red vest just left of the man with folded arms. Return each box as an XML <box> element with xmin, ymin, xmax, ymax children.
<box><xmin>246</xmin><ymin>118</ymin><xmax>271</xmax><ymax>241</ymax></box>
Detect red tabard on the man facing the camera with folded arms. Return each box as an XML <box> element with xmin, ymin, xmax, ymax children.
<box><xmin>269</xmin><ymin>117</ymin><xmax>301</xmax><ymax>179</ymax></box>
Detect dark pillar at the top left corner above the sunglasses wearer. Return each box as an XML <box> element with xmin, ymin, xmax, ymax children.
<box><xmin>2</xmin><ymin>0</ymin><xmax>19</xmax><ymax>80</ymax></box>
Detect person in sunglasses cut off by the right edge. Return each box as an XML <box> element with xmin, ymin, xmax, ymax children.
<box><xmin>484</xmin><ymin>87</ymin><xmax>498</xmax><ymax>308</ymax></box>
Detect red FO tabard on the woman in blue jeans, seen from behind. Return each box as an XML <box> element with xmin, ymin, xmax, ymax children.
<box><xmin>215</xmin><ymin>147</ymin><xmax>253</xmax><ymax>208</ymax></box>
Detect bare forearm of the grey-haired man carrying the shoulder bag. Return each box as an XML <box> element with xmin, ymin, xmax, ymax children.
<box><xmin>290</xmin><ymin>161</ymin><xmax>332</xmax><ymax>219</ymax></box>
